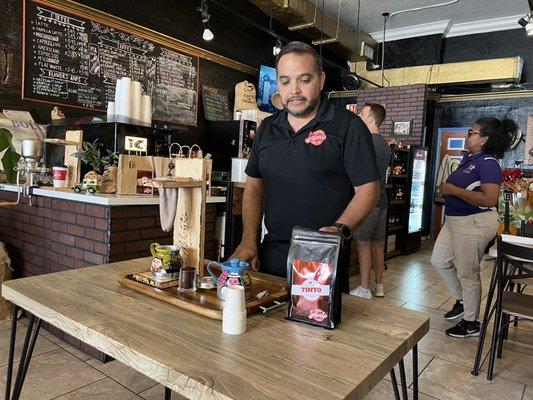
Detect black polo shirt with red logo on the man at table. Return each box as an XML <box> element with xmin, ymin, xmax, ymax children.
<box><xmin>246</xmin><ymin>97</ymin><xmax>379</xmax><ymax>244</ymax></box>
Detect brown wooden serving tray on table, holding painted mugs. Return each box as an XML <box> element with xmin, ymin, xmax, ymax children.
<box><xmin>118</xmin><ymin>271</ymin><xmax>287</xmax><ymax>320</ymax></box>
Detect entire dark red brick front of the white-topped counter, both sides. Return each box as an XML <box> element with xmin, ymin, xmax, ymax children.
<box><xmin>0</xmin><ymin>190</ymin><xmax>216</xmax><ymax>361</ymax></box>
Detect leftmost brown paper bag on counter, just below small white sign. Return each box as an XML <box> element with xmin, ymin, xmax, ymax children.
<box><xmin>117</xmin><ymin>154</ymin><xmax>154</xmax><ymax>195</ymax></box>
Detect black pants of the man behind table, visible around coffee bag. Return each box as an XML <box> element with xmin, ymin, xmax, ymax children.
<box><xmin>259</xmin><ymin>240</ymin><xmax>351</xmax><ymax>293</ymax></box>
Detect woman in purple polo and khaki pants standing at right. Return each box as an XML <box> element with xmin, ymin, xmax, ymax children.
<box><xmin>431</xmin><ymin>118</ymin><xmax>518</xmax><ymax>338</ymax></box>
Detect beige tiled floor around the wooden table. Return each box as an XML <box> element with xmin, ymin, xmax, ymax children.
<box><xmin>0</xmin><ymin>242</ymin><xmax>533</xmax><ymax>400</ymax></box>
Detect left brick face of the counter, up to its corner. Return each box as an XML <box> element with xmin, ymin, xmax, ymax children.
<box><xmin>0</xmin><ymin>191</ymin><xmax>109</xmax><ymax>277</ymax></box>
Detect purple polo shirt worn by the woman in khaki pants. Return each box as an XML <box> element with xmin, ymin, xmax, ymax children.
<box><xmin>444</xmin><ymin>153</ymin><xmax>502</xmax><ymax>216</ymax></box>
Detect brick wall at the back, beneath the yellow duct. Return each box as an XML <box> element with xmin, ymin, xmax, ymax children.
<box><xmin>357</xmin><ymin>84</ymin><xmax>427</xmax><ymax>144</ymax></box>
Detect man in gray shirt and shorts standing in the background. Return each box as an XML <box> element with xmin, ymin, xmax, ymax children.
<box><xmin>350</xmin><ymin>103</ymin><xmax>392</xmax><ymax>299</ymax></box>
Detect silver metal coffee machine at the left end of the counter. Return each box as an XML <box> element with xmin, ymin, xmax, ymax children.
<box><xmin>15</xmin><ymin>139</ymin><xmax>50</xmax><ymax>206</ymax></box>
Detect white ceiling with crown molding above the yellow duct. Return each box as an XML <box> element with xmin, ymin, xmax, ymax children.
<box><xmin>318</xmin><ymin>0</ymin><xmax>529</xmax><ymax>41</ymax></box>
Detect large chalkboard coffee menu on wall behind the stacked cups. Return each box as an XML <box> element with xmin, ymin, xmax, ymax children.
<box><xmin>23</xmin><ymin>0</ymin><xmax>198</xmax><ymax>125</ymax></box>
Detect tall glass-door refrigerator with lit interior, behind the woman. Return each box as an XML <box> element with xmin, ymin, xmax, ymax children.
<box><xmin>402</xmin><ymin>146</ymin><xmax>428</xmax><ymax>254</ymax></box>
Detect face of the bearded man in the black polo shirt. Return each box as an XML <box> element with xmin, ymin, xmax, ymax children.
<box><xmin>277</xmin><ymin>53</ymin><xmax>325</xmax><ymax>118</ymax></box>
